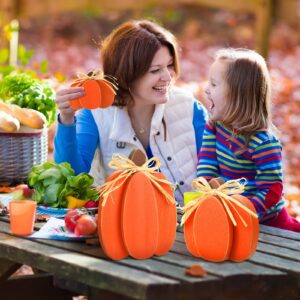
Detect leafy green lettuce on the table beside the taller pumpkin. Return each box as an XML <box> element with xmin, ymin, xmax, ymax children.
<box><xmin>28</xmin><ymin>162</ymin><xmax>99</xmax><ymax>207</ymax></box>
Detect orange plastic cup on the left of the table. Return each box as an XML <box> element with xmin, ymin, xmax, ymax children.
<box><xmin>9</xmin><ymin>200</ymin><xmax>36</xmax><ymax>235</ymax></box>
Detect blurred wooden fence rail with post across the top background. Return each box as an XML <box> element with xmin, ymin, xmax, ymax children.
<box><xmin>0</xmin><ymin>0</ymin><xmax>299</xmax><ymax>57</ymax></box>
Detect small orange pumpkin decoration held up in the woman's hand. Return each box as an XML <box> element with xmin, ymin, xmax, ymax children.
<box><xmin>70</xmin><ymin>71</ymin><xmax>117</xmax><ymax>110</ymax></box>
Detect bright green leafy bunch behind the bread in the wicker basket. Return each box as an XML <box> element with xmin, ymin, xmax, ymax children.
<box><xmin>0</xmin><ymin>73</ymin><xmax>56</xmax><ymax>126</ymax></box>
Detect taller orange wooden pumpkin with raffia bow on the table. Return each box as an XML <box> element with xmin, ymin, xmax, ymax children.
<box><xmin>98</xmin><ymin>154</ymin><xmax>177</xmax><ymax>260</ymax></box>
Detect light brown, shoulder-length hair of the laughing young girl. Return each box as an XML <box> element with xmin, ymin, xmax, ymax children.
<box><xmin>216</xmin><ymin>48</ymin><xmax>276</xmax><ymax>153</ymax></box>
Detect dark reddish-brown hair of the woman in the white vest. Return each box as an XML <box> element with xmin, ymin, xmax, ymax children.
<box><xmin>101</xmin><ymin>20</ymin><xmax>179</xmax><ymax>106</ymax></box>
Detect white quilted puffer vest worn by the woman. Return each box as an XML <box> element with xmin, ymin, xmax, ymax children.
<box><xmin>90</xmin><ymin>87</ymin><xmax>197</xmax><ymax>204</ymax></box>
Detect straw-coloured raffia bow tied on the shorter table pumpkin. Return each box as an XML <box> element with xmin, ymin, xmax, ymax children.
<box><xmin>181</xmin><ymin>177</ymin><xmax>258</xmax><ymax>227</ymax></box>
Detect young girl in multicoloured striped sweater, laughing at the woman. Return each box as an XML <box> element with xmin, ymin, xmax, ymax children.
<box><xmin>197</xmin><ymin>49</ymin><xmax>300</xmax><ymax>232</ymax></box>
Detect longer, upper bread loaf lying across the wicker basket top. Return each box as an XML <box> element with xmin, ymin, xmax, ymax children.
<box><xmin>0</xmin><ymin>101</ymin><xmax>46</xmax><ymax>129</ymax></box>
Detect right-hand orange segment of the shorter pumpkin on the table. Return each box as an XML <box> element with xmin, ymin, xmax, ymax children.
<box><xmin>230</xmin><ymin>195</ymin><xmax>259</xmax><ymax>261</ymax></box>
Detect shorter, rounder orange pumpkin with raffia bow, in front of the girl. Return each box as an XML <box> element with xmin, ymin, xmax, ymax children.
<box><xmin>181</xmin><ymin>177</ymin><xmax>259</xmax><ymax>262</ymax></box>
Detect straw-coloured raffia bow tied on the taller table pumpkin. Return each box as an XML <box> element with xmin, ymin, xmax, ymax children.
<box><xmin>100</xmin><ymin>154</ymin><xmax>176</xmax><ymax>207</ymax></box>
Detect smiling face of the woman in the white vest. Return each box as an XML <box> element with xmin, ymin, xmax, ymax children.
<box><xmin>131</xmin><ymin>46</ymin><xmax>175</xmax><ymax>105</ymax></box>
